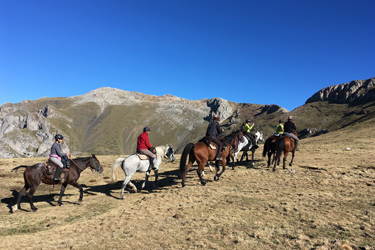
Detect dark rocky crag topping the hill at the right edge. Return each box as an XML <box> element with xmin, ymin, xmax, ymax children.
<box><xmin>306</xmin><ymin>78</ymin><xmax>375</xmax><ymax>105</ymax></box>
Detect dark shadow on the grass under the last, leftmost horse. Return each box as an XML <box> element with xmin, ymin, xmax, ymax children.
<box><xmin>1</xmin><ymin>189</ymin><xmax>76</xmax><ymax>213</ymax></box>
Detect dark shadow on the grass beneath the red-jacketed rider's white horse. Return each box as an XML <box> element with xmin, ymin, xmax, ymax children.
<box><xmin>81</xmin><ymin>167</ymin><xmax>179</xmax><ymax>200</ymax></box>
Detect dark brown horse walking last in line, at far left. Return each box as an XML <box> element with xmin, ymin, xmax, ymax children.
<box><xmin>12</xmin><ymin>155</ymin><xmax>103</xmax><ymax>212</ymax></box>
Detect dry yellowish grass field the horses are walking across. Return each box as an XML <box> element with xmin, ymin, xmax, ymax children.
<box><xmin>0</xmin><ymin>123</ymin><xmax>375</xmax><ymax>249</ymax></box>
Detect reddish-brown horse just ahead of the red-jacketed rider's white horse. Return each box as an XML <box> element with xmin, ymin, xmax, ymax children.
<box><xmin>180</xmin><ymin>131</ymin><xmax>242</xmax><ymax>187</ymax></box>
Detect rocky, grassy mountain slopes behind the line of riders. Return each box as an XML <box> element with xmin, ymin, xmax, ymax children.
<box><xmin>0</xmin><ymin>78</ymin><xmax>375</xmax><ymax>158</ymax></box>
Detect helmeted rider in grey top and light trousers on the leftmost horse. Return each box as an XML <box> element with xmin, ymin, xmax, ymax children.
<box><xmin>49</xmin><ymin>134</ymin><xmax>70</xmax><ymax>181</ymax></box>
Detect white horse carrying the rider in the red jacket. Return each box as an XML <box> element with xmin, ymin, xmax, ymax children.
<box><xmin>111</xmin><ymin>144</ymin><xmax>175</xmax><ymax>199</ymax></box>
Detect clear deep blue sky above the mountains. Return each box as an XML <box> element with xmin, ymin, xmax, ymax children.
<box><xmin>0</xmin><ymin>0</ymin><xmax>375</xmax><ymax>110</ymax></box>
